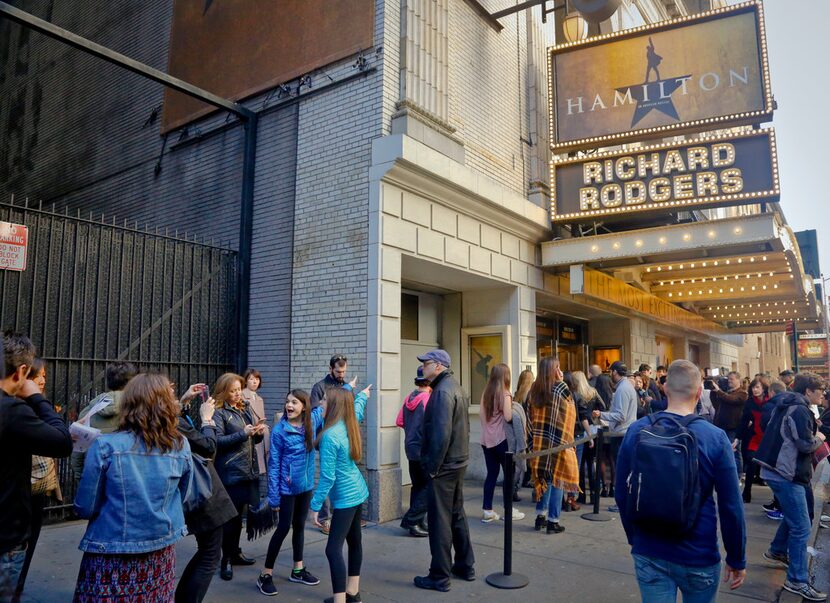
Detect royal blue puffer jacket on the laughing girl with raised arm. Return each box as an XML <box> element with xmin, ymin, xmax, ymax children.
<box><xmin>268</xmin><ymin>406</ymin><xmax>323</xmax><ymax>508</ymax></box>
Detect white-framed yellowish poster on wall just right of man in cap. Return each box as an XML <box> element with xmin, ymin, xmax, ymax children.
<box><xmin>461</xmin><ymin>325</ymin><xmax>512</xmax><ymax>406</ymax></box>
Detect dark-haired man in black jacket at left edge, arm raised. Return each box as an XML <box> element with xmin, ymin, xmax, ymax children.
<box><xmin>0</xmin><ymin>332</ymin><xmax>72</xmax><ymax>601</ymax></box>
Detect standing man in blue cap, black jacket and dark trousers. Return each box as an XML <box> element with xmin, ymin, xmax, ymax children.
<box><xmin>415</xmin><ymin>350</ymin><xmax>475</xmax><ymax>592</ymax></box>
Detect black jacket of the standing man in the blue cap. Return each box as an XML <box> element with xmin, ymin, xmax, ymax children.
<box><xmin>421</xmin><ymin>370</ymin><xmax>470</xmax><ymax>477</ymax></box>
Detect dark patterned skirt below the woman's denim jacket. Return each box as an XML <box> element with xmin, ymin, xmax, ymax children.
<box><xmin>72</xmin><ymin>545</ymin><xmax>176</xmax><ymax>603</ymax></box>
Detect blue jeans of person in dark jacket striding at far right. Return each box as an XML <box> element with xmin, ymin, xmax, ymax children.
<box><xmin>767</xmin><ymin>479</ymin><xmax>810</xmax><ymax>584</ymax></box>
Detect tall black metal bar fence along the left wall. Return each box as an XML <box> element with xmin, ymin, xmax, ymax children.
<box><xmin>0</xmin><ymin>199</ymin><xmax>238</xmax><ymax>511</ymax></box>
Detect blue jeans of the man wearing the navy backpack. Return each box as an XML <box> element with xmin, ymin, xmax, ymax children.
<box><xmin>632</xmin><ymin>555</ymin><xmax>720</xmax><ymax>603</ymax></box>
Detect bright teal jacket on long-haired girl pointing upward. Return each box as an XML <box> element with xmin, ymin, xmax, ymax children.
<box><xmin>311</xmin><ymin>392</ymin><xmax>369</xmax><ymax>511</ymax></box>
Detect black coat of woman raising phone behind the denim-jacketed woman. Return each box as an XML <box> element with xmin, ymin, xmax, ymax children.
<box><xmin>179</xmin><ymin>417</ymin><xmax>236</xmax><ymax>534</ymax></box>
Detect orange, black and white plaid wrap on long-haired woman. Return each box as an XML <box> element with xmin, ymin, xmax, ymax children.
<box><xmin>530</xmin><ymin>382</ymin><xmax>579</xmax><ymax>500</ymax></box>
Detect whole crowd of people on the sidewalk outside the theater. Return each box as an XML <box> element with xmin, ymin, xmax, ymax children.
<box><xmin>0</xmin><ymin>332</ymin><xmax>830</xmax><ymax>603</ymax></box>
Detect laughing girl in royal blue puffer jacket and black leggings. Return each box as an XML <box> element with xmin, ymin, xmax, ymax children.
<box><xmin>257</xmin><ymin>389</ymin><xmax>324</xmax><ymax>596</ymax></box>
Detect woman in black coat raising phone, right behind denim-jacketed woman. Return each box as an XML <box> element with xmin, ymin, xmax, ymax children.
<box><xmin>175</xmin><ymin>383</ymin><xmax>237</xmax><ymax>603</ymax></box>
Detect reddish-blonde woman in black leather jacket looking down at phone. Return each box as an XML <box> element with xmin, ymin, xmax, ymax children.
<box><xmin>213</xmin><ymin>373</ymin><xmax>265</xmax><ymax>580</ymax></box>
